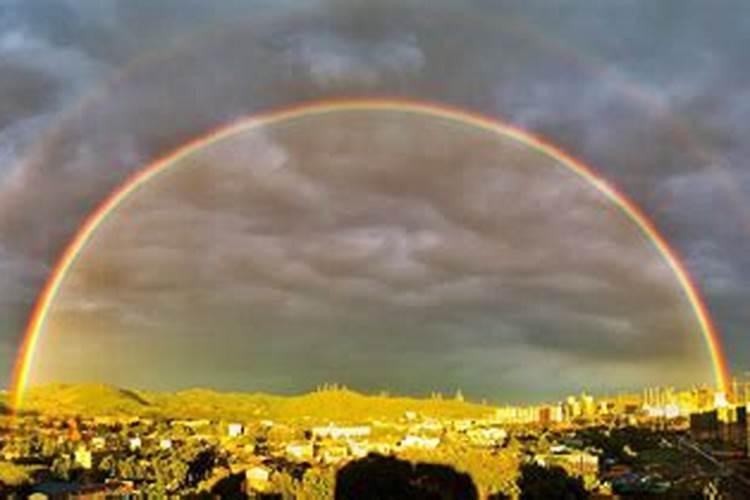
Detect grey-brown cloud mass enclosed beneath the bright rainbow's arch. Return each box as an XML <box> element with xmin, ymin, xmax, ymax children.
<box><xmin>33</xmin><ymin>112</ymin><xmax>702</xmax><ymax>394</ymax></box>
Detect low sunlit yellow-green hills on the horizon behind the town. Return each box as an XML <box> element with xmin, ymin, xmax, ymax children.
<box><xmin>17</xmin><ymin>384</ymin><xmax>493</xmax><ymax>422</ymax></box>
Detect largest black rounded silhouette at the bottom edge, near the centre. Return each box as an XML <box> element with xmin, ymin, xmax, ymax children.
<box><xmin>335</xmin><ymin>454</ymin><xmax>478</xmax><ymax>500</ymax></box>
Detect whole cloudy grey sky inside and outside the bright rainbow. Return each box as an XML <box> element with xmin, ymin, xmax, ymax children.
<box><xmin>0</xmin><ymin>0</ymin><xmax>750</xmax><ymax>400</ymax></box>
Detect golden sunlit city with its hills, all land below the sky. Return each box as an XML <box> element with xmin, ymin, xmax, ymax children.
<box><xmin>0</xmin><ymin>372</ymin><xmax>750</xmax><ymax>499</ymax></box>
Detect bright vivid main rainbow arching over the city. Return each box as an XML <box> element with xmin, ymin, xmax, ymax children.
<box><xmin>10</xmin><ymin>98</ymin><xmax>731</xmax><ymax>409</ymax></box>
